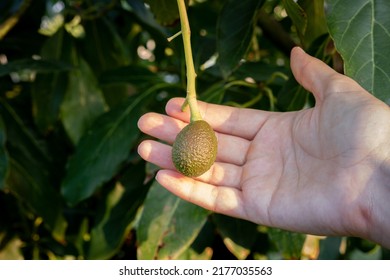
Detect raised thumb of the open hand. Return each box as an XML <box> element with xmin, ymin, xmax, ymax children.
<box><xmin>291</xmin><ymin>47</ymin><xmax>346</xmax><ymax>101</ymax></box>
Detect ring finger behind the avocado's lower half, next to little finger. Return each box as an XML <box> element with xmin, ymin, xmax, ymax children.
<box><xmin>138</xmin><ymin>140</ymin><xmax>242</xmax><ymax>188</ymax></box>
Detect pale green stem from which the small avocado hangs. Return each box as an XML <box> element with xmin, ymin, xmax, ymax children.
<box><xmin>177</xmin><ymin>0</ymin><xmax>203</xmax><ymax>122</ymax></box>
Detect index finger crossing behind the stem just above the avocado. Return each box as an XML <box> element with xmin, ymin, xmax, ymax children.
<box><xmin>165</xmin><ymin>98</ymin><xmax>276</xmax><ymax>140</ymax></box>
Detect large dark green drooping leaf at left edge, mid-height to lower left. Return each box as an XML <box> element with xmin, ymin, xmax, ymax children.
<box><xmin>0</xmin><ymin>99</ymin><xmax>67</xmax><ymax>241</ymax></box>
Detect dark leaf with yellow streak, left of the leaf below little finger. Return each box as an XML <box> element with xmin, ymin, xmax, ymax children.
<box><xmin>88</xmin><ymin>163</ymin><xmax>148</xmax><ymax>260</ymax></box>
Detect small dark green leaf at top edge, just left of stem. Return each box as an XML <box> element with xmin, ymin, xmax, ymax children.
<box><xmin>144</xmin><ymin>0</ymin><xmax>188</xmax><ymax>25</ymax></box>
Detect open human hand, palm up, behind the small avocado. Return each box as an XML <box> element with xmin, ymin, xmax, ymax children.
<box><xmin>138</xmin><ymin>48</ymin><xmax>390</xmax><ymax>245</ymax></box>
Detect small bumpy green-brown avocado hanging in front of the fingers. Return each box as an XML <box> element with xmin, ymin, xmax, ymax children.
<box><xmin>172</xmin><ymin>120</ymin><xmax>217</xmax><ymax>177</ymax></box>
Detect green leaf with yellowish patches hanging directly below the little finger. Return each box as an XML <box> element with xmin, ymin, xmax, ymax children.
<box><xmin>137</xmin><ymin>182</ymin><xmax>209</xmax><ymax>259</ymax></box>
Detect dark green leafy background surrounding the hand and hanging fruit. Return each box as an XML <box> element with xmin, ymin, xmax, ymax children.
<box><xmin>0</xmin><ymin>0</ymin><xmax>390</xmax><ymax>259</ymax></box>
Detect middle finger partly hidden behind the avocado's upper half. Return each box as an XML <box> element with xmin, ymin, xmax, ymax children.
<box><xmin>138</xmin><ymin>113</ymin><xmax>250</xmax><ymax>165</ymax></box>
